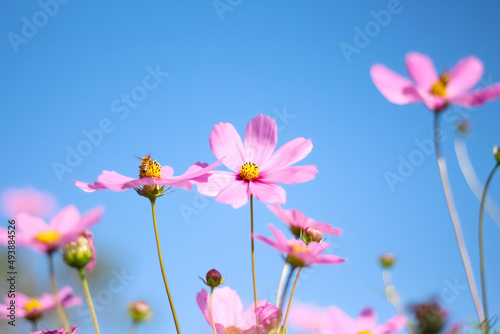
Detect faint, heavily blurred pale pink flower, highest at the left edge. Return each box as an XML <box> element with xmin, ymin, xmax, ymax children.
<box><xmin>2</xmin><ymin>187</ymin><xmax>57</xmax><ymax>217</ymax></box>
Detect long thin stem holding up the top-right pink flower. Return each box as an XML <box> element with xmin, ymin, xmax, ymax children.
<box><xmin>434</xmin><ymin>111</ymin><xmax>484</xmax><ymax>323</ymax></box>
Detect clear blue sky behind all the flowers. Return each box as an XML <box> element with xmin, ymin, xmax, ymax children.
<box><xmin>0</xmin><ymin>0</ymin><xmax>500</xmax><ymax>333</ymax></box>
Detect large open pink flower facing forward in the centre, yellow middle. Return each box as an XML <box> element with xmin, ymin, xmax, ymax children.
<box><xmin>197</xmin><ymin>114</ymin><xmax>318</xmax><ymax>208</ymax></box>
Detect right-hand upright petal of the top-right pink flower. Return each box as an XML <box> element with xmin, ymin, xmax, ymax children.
<box><xmin>446</xmin><ymin>57</ymin><xmax>484</xmax><ymax>97</ymax></box>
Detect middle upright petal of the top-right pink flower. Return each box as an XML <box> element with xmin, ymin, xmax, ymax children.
<box><xmin>406</xmin><ymin>52</ymin><xmax>439</xmax><ymax>90</ymax></box>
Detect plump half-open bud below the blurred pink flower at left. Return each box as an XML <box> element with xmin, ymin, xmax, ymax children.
<box><xmin>63</xmin><ymin>231</ymin><xmax>97</xmax><ymax>271</ymax></box>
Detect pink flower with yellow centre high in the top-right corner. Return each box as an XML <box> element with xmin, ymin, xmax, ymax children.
<box><xmin>370</xmin><ymin>52</ymin><xmax>500</xmax><ymax>111</ymax></box>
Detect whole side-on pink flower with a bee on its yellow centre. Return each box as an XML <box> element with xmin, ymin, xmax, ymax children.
<box><xmin>74</xmin><ymin>156</ymin><xmax>222</xmax><ymax>197</ymax></box>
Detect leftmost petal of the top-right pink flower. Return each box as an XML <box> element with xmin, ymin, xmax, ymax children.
<box><xmin>370</xmin><ymin>64</ymin><xmax>421</xmax><ymax>104</ymax></box>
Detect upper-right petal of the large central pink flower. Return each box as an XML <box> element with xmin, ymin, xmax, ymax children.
<box><xmin>260</xmin><ymin>138</ymin><xmax>313</xmax><ymax>170</ymax></box>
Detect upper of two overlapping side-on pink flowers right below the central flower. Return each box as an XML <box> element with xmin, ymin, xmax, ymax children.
<box><xmin>267</xmin><ymin>204</ymin><xmax>342</xmax><ymax>238</ymax></box>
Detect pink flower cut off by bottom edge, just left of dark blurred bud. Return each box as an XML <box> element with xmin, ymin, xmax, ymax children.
<box><xmin>320</xmin><ymin>306</ymin><xmax>407</xmax><ymax>334</ymax></box>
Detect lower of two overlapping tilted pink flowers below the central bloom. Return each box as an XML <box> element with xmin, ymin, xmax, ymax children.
<box><xmin>253</xmin><ymin>224</ymin><xmax>345</xmax><ymax>267</ymax></box>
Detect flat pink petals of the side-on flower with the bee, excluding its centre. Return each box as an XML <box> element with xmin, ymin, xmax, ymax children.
<box><xmin>74</xmin><ymin>161</ymin><xmax>222</xmax><ymax>192</ymax></box>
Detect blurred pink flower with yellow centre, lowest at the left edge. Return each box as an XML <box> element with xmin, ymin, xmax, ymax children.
<box><xmin>0</xmin><ymin>286</ymin><xmax>82</xmax><ymax>320</ymax></box>
